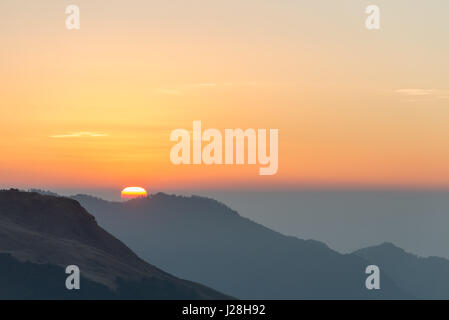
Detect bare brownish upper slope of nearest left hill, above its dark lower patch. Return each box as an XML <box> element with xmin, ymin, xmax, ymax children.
<box><xmin>0</xmin><ymin>189</ymin><xmax>230</xmax><ymax>299</ymax></box>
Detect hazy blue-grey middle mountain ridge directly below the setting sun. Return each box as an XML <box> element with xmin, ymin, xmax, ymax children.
<box><xmin>73</xmin><ymin>193</ymin><xmax>412</xmax><ymax>299</ymax></box>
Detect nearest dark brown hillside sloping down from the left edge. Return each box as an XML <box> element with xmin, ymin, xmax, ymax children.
<box><xmin>0</xmin><ymin>190</ymin><xmax>228</xmax><ymax>299</ymax></box>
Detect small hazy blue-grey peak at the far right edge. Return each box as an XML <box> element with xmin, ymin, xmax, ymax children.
<box><xmin>354</xmin><ymin>243</ymin><xmax>449</xmax><ymax>299</ymax></box>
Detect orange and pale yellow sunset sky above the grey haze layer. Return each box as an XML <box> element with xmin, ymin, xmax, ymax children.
<box><xmin>0</xmin><ymin>0</ymin><xmax>449</xmax><ymax>189</ymax></box>
